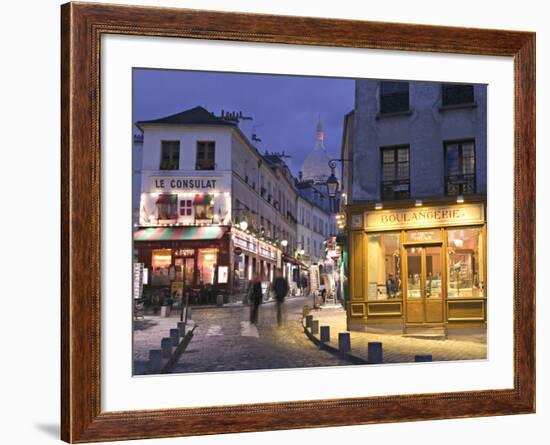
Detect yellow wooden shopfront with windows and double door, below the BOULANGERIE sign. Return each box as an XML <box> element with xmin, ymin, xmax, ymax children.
<box><xmin>348</xmin><ymin>203</ymin><xmax>487</xmax><ymax>331</ymax></box>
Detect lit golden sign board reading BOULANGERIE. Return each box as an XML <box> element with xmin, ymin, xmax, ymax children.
<box><xmin>365</xmin><ymin>204</ymin><xmax>485</xmax><ymax>231</ymax></box>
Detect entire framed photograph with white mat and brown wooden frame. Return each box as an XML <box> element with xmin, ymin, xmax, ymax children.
<box><xmin>61</xmin><ymin>3</ymin><xmax>535</xmax><ymax>443</ymax></box>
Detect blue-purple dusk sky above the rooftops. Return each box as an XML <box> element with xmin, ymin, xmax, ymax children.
<box><xmin>133</xmin><ymin>69</ymin><xmax>355</xmax><ymax>176</ymax></box>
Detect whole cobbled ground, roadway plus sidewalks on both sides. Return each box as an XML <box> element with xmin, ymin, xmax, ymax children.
<box><xmin>133</xmin><ymin>297</ymin><xmax>487</xmax><ymax>375</ymax></box>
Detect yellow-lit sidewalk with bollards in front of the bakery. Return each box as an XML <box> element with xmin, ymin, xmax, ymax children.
<box><xmin>310</xmin><ymin>307</ymin><xmax>487</xmax><ymax>363</ymax></box>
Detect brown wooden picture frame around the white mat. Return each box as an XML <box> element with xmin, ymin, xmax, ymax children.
<box><xmin>61</xmin><ymin>3</ymin><xmax>535</xmax><ymax>443</ymax></box>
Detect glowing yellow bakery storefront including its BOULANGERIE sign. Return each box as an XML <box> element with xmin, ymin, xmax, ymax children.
<box><xmin>347</xmin><ymin>197</ymin><xmax>487</xmax><ymax>333</ymax></box>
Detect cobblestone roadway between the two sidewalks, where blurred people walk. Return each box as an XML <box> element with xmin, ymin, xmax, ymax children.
<box><xmin>172</xmin><ymin>297</ymin><xmax>349</xmax><ymax>373</ymax></box>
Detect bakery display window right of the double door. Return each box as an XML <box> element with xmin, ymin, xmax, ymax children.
<box><xmin>447</xmin><ymin>228</ymin><xmax>485</xmax><ymax>298</ymax></box>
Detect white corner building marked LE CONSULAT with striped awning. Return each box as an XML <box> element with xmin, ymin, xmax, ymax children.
<box><xmin>134</xmin><ymin>107</ymin><xmax>304</xmax><ymax>303</ymax></box>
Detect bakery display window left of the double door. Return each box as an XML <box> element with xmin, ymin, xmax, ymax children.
<box><xmin>367</xmin><ymin>233</ymin><xmax>402</xmax><ymax>300</ymax></box>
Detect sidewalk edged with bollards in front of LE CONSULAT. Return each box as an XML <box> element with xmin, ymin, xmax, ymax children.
<box><xmin>133</xmin><ymin>314</ymin><xmax>195</xmax><ymax>375</ymax></box>
